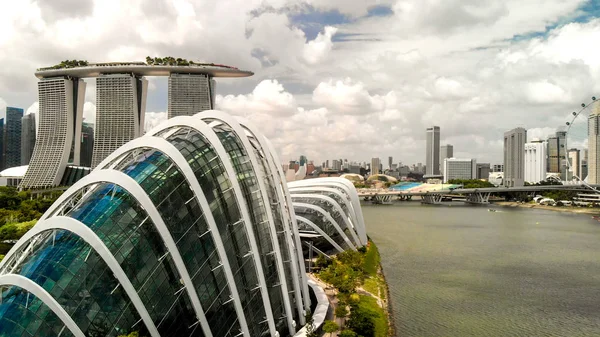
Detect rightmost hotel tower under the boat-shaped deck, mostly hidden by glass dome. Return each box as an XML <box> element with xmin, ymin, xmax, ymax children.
<box><xmin>168</xmin><ymin>73</ymin><xmax>214</xmax><ymax>118</ymax></box>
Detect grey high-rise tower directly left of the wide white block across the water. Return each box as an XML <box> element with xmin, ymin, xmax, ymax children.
<box><xmin>504</xmin><ymin>128</ymin><xmax>527</xmax><ymax>187</ymax></box>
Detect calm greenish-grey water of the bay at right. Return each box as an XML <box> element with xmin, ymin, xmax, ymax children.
<box><xmin>363</xmin><ymin>202</ymin><xmax>600</xmax><ymax>337</ymax></box>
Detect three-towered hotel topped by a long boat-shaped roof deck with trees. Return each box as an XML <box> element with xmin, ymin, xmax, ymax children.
<box><xmin>20</xmin><ymin>61</ymin><xmax>253</xmax><ymax>189</ymax></box>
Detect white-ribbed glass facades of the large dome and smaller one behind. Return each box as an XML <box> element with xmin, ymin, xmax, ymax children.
<box><xmin>0</xmin><ymin>111</ymin><xmax>368</xmax><ymax>337</ymax></box>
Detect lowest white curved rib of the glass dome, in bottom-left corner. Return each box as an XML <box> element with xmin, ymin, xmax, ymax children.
<box><xmin>0</xmin><ymin>274</ymin><xmax>85</xmax><ymax>337</ymax></box>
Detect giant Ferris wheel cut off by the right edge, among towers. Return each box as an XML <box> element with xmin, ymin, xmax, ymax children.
<box><xmin>561</xmin><ymin>96</ymin><xmax>600</xmax><ymax>193</ymax></box>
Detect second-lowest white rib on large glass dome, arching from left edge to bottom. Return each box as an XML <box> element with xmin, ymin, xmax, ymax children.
<box><xmin>0</xmin><ymin>217</ymin><xmax>160</xmax><ymax>337</ymax></box>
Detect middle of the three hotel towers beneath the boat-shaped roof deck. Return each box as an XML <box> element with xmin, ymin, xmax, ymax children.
<box><xmin>92</xmin><ymin>74</ymin><xmax>148</xmax><ymax>167</ymax></box>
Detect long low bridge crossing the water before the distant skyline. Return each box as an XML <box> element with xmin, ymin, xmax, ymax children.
<box><xmin>358</xmin><ymin>184</ymin><xmax>600</xmax><ymax>204</ymax></box>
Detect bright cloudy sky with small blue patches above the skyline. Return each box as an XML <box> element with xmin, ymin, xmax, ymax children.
<box><xmin>0</xmin><ymin>0</ymin><xmax>600</xmax><ymax>164</ymax></box>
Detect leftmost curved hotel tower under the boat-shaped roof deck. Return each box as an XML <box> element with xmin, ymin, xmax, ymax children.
<box><xmin>20</xmin><ymin>77</ymin><xmax>85</xmax><ymax>188</ymax></box>
